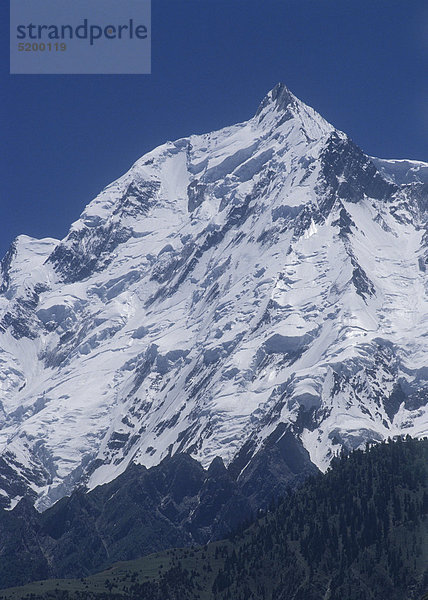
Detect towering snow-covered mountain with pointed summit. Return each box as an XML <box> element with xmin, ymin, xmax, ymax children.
<box><xmin>0</xmin><ymin>84</ymin><xmax>428</xmax><ymax>508</ymax></box>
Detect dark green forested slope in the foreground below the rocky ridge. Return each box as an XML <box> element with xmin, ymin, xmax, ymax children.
<box><xmin>0</xmin><ymin>438</ymin><xmax>428</xmax><ymax>600</ymax></box>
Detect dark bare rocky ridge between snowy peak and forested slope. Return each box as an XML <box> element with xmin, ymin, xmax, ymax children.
<box><xmin>0</xmin><ymin>433</ymin><xmax>318</xmax><ymax>588</ymax></box>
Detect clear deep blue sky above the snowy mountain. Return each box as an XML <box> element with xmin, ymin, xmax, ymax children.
<box><xmin>0</xmin><ymin>0</ymin><xmax>428</xmax><ymax>256</ymax></box>
